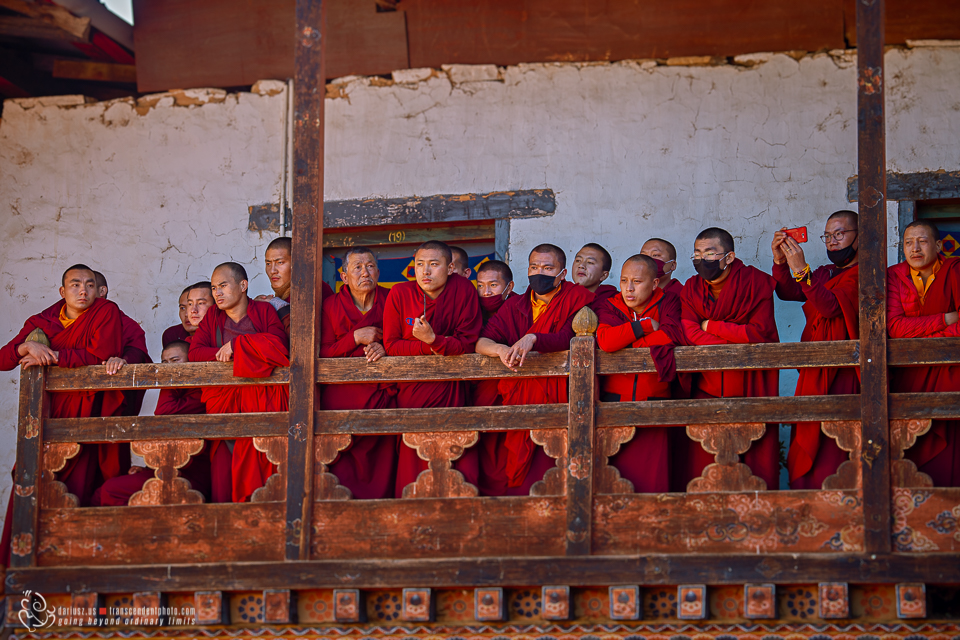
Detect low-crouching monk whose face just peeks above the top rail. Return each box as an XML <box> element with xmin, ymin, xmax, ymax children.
<box><xmin>93</xmin><ymin>340</ymin><xmax>218</xmax><ymax>507</ymax></box>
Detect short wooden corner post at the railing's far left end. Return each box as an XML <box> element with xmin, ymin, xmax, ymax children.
<box><xmin>10</xmin><ymin>367</ymin><xmax>50</xmax><ymax>568</ymax></box>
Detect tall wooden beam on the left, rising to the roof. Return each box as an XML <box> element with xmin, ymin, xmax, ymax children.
<box><xmin>286</xmin><ymin>0</ymin><xmax>327</xmax><ymax>560</ymax></box>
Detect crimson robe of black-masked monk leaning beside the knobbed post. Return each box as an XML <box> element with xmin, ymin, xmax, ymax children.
<box><xmin>478</xmin><ymin>281</ymin><xmax>594</xmax><ymax>496</ymax></box>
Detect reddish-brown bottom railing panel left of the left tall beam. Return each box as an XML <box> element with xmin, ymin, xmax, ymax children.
<box><xmin>37</xmin><ymin>502</ymin><xmax>284</xmax><ymax>564</ymax></box>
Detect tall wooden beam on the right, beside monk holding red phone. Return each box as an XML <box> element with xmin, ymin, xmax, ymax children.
<box><xmin>856</xmin><ymin>0</ymin><xmax>891</xmax><ymax>553</ymax></box>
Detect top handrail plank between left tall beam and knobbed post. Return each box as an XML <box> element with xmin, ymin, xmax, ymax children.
<box><xmin>317</xmin><ymin>351</ymin><xmax>570</xmax><ymax>383</ymax></box>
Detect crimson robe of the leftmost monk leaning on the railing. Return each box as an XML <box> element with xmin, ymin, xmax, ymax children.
<box><xmin>0</xmin><ymin>299</ymin><xmax>130</xmax><ymax>506</ymax></box>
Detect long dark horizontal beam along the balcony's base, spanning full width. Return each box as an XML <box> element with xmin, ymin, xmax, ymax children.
<box><xmin>6</xmin><ymin>553</ymin><xmax>956</xmax><ymax>593</ymax></box>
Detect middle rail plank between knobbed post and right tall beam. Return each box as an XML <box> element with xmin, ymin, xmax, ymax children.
<box><xmin>597</xmin><ymin>395</ymin><xmax>860</xmax><ymax>428</ymax></box>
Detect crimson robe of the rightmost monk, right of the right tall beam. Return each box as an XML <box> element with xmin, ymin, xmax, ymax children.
<box><xmin>887</xmin><ymin>258</ymin><xmax>960</xmax><ymax>487</ymax></box>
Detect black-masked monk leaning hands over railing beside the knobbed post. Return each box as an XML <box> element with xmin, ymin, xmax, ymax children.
<box><xmin>477</xmin><ymin>244</ymin><xmax>594</xmax><ymax>496</ymax></box>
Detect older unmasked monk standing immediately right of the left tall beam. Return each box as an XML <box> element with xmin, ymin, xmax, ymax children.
<box><xmin>320</xmin><ymin>247</ymin><xmax>399</xmax><ymax>500</ymax></box>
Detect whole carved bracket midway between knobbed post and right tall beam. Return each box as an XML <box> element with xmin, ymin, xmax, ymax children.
<box><xmin>687</xmin><ymin>422</ymin><xmax>767</xmax><ymax>493</ymax></box>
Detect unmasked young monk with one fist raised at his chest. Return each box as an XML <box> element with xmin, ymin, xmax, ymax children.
<box><xmin>383</xmin><ymin>240</ymin><xmax>482</xmax><ymax>498</ymax></box>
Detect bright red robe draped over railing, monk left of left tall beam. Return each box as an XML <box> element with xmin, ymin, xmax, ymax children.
<box><xmin>190</xmin><ymin>298</ymin><xmax>290</xmax><ymax>502</ymax></box>
